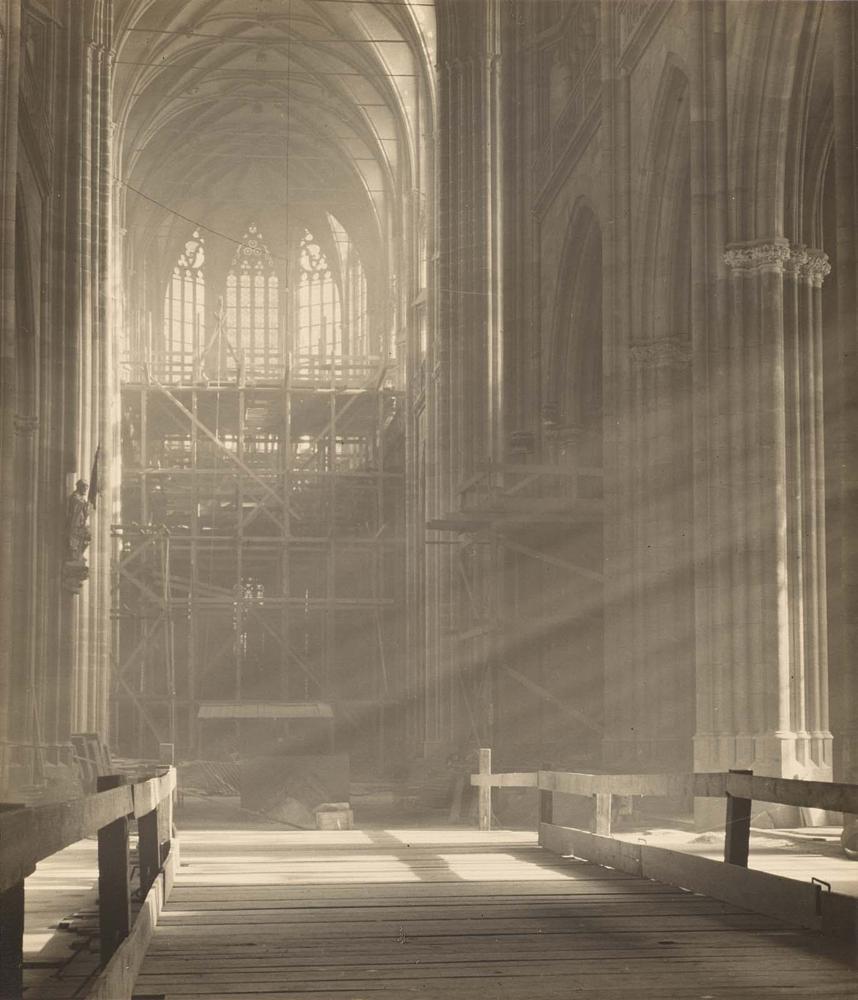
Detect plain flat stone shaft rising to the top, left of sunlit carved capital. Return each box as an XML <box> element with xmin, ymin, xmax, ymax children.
<box><xmin>689</xmin><ymin>0</ymin><xmax>728</xmax><ymax>792</ymax></box>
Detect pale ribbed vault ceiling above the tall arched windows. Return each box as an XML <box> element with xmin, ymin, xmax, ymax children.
<box><xmin>113</xmin><ymin>0</ymin><xmax>434</xmax><ymax>262</ymax></box>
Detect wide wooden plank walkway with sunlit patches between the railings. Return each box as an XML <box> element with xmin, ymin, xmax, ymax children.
<box><xmin>135</xmin><ymin>830</ymin><xmax>858</xmax><ymax>1000</ymax></box>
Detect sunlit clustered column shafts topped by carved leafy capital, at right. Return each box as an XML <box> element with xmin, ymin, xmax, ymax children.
<box><xmin>695</xmin><ymin>238</ymin><xmax>831</xmax><ymax>779</ymax></box>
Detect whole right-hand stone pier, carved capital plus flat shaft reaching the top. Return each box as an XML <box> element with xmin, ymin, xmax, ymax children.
<box><xmin>689</xmin><ymin>0</ymin><xmax>831</xmax><ymax>796</ymax></box>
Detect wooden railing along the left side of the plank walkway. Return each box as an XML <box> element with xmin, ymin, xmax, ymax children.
<box><xmin>0</xmin><ymin>767</ymin><xmax>178</xmax><ymax>1000</ymax></box>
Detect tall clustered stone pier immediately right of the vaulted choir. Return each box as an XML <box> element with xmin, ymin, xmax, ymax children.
<box><xmin>424</xmin><ymin>0</ymin><xmax>503</xmax><ymax>752</ymax></box>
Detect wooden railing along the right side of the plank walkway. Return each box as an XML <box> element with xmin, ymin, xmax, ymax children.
<box><xmin>471</xmin><ymin>749</ymin><xmax>858</xmax><ymax>949</ymax></box>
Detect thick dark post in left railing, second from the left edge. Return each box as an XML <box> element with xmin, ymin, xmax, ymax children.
<box><xmin>97</xmin><ymin>774</ymin><xmax>131</xmax><ymax>965</ymax></box>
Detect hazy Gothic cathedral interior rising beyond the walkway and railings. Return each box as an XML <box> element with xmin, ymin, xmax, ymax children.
<box><xmin>0</xmin><ymin>0</ymin><xmax>858</xmax><ymax>828</ymax></box>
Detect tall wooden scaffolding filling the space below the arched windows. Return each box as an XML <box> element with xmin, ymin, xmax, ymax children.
<box><xmin>114</xmin><ymin>357</ymin><xmax>405</xmax><ymax>762</ymax></box>
